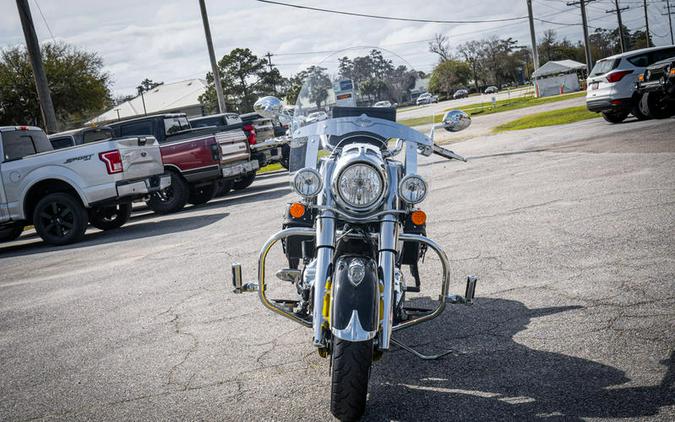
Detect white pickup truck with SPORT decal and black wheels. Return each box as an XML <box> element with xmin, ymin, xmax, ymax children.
<box><xmin>0</xmin><ymin>126</ymin><xmax>171</xmax><ymax>245</ymax></box>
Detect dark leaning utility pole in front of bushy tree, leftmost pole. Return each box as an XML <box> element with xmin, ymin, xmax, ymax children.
<box><xmin>16</xmin><ymin>0</ymin><xmax>58</xmax><ymax>133</ymax></box>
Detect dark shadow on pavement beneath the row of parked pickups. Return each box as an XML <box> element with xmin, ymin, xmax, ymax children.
<box><xmin>0</xmin><ymin>213</ymin><xmax>229</xmax><ymax>258</ymax></box>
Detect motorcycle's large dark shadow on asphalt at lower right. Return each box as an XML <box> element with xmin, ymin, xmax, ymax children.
<box><xmin>364</xmin><ymin>299</ymin><xmax>675</xmax><ymax>421</ymax></box>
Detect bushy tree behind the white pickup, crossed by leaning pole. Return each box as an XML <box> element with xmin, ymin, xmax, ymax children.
<box><xmin>0</xmin><ymin>43</ymin><xmax>112</xmax><ymax>128</ymax></box>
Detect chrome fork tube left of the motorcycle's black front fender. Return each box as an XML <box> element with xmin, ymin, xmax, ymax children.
<box><xmin>312</xmin><ymin>160</ymin><xmax>335</xmax><ymax>347</ymax></box>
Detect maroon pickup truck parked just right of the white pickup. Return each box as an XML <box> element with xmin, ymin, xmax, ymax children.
<box><xmin>108</xmin><ymin>113</ymin><xmax>258</xmax><ymax>214</ymax></box>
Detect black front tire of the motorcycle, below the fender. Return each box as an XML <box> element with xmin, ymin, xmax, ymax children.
<box><xmin>330</xmin><ymin>338</ymin><xmax>373</xmax><ymax>421</ymax></box>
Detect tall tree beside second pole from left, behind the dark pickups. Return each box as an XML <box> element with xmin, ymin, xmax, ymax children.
<box><xmin>199</xmin><ymin>48</ymin><xmax>284</xmax><ymax>113</ymax></box>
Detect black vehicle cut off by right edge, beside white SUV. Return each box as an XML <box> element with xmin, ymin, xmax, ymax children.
<box><xmin>637</xmin><ymin>57</ymin><xmax>675</xmax><ymax>119</ymax></box>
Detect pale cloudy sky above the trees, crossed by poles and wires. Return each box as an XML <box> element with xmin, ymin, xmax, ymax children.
<box><xmin>0</xmin><ymin>0</ymin><xmax>675</xmax><ymax>95</ymax></box>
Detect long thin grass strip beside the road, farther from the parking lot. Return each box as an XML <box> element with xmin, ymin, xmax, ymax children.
<box><xmin>398</xmin><ymin>91</ymin><xmax>586</xmax><ymax>126</ymax></box>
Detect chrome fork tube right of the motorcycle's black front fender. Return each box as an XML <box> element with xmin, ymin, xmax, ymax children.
<box><xmin>378</xmin><ymin>164</ymin><xmax>400</xmax><ymax>350</ymax></box>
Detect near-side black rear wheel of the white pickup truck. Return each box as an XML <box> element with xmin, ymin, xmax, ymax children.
<box><xmin>33</xmin><ymin>192</ymin><xmax>88</xmax><ymax>245</ymax></box>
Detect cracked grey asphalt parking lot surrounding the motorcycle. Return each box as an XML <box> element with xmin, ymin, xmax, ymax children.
<box><xmin>0</xmin><ymin>119</ymin><xmax>675</xmax><ymax>421</ymax></box>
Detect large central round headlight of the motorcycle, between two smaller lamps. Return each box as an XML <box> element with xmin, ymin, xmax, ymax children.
<box><xmin>337</xmin><ymin>163</ymin><xmax>384</xmax><ymax>208</ymax></box>
